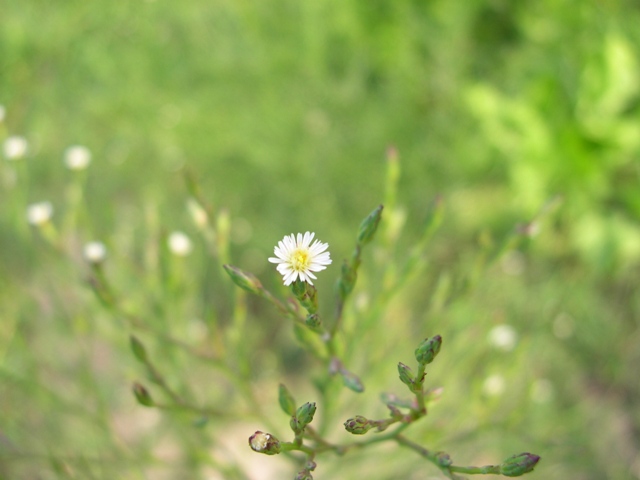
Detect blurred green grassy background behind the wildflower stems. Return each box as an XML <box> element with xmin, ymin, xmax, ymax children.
<box><xmin>0</xmin><ymin>0</ymin><xmax>640</xmax><ymax>480</ymax></box>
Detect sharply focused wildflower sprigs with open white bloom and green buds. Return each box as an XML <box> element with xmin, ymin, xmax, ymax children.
<box><xmin>224</xmin><ymin>210</ymin><xmax>540</xmax><ymax>480</ymax></box>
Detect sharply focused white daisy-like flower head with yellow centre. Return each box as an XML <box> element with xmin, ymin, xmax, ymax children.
<box><xmin>269</xmin><ymin>232</ymin><xmax>331</xmax><ymax>285</ymax></box>
